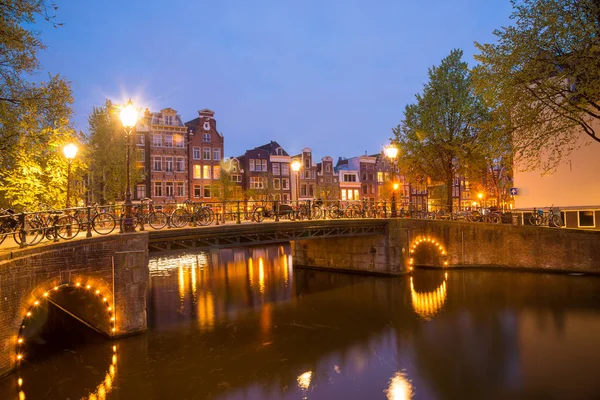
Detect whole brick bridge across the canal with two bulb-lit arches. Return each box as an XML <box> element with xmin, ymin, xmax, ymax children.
<box><xmin>0</xmin><ymin>219</ymin><xmax>600</xmax><ymax>375</ymax></box>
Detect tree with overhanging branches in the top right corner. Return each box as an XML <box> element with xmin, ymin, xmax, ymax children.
<box><xmin>474</xmin><ymin>0</ymin><xmax>600</xmax><ymax>172</ymax></box>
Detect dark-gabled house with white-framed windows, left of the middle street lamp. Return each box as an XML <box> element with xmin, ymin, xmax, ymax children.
<box><xmin>237</xmin><ymin>141</ymin><xmax>292</xmax><ymax>202</ymax></box>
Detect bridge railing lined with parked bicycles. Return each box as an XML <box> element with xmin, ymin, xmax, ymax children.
<box><xmin>0</xmin><ymin>199</ymin><xmax>511</xmax><ymax>247</ymax></box>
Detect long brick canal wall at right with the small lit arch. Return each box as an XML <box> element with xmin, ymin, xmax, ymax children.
<box><xmin>292</xmin><ymin>219</ymin><xmax>600</xmax><ymax>275</ymax></box>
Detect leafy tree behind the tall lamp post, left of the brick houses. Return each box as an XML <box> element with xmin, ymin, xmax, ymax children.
<box><xmin>88</xmin><ymin>100</ymin><xmax>143</xmax><ymax>204</ymax></box>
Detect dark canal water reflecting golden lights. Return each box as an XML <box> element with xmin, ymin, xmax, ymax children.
<box><xmin>0</xmin><ymin>246</ymin><xmax>600</xmax><ymax>400</ymax></box>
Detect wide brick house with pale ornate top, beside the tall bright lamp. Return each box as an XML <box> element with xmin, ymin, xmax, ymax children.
<box><xmin>143</xmin><ymin>108</ymin><xmax>188</xmax><ymax>204</ymax></box>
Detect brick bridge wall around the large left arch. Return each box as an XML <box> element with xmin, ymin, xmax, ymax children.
<box><xmin>0</xmin><ymin>232</ymin><xmax>148</xmax><ymax>375</ymax></box>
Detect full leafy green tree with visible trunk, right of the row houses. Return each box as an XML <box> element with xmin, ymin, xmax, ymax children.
<box><xmin>393</xmin><ymin>50</ymin><xmax>486</xmax><ymax>210</ymax></box>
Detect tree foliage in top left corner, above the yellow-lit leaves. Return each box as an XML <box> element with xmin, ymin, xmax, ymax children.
<box><xmin>0</xmin><ymin>0</ymin><xmax>73</xmax><ymax>156</ymax></box>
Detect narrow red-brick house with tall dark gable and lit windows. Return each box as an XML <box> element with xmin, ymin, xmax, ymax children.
<box><xmin>185</xmin><ymin>108</ymin><xmax>225</xmax><ymax>200</ymax></box>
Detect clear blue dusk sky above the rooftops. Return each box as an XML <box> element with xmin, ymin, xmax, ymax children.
<box><xmin>37</xmin><ymin>0</ymin><xmax>511</xmax><ymax>158</ymax></box>
